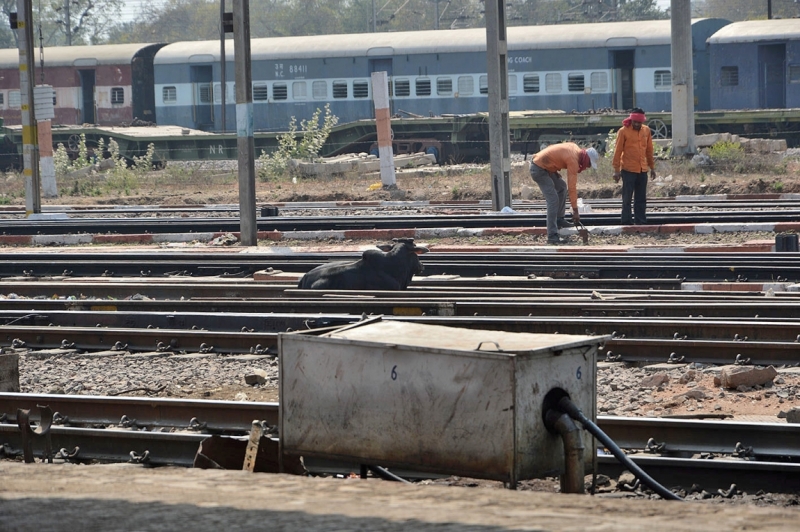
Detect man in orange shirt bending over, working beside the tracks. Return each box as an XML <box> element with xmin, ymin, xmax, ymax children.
<box><xmin>531</xmin><ymin>142</ymin><xmax>600</xmax><ymax>244</ymax></box>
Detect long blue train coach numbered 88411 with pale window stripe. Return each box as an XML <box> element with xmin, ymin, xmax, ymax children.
<box><xmin>154</xmin><ymin>19</ymin><xmax>729</xmax><ymax>135</ymax></box>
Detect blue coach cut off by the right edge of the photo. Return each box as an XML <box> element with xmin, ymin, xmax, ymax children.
<box><xmin>708</xmin><ymin>19</ymin><xmax>800</xmax><ymax>109</ymax></box>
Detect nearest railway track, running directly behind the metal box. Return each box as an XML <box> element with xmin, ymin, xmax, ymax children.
<box><xmin>0</xmin><ymin>393</ymin><xmax>800</xmax><ymax>492</ymax></box>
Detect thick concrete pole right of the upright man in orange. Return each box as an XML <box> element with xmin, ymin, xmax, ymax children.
<box><xmin>670</xmin><ymin>0</ymin><xmax>696</xmax><ymax>155</ymax></box>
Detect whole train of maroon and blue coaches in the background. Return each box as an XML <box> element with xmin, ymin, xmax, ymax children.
<box><xmin>0</xmin><ymin>19</ymin><xmax>800</xmax><ymax>136</ymax></box>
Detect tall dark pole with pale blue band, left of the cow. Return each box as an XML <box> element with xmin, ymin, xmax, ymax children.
<box><xmin>233</xmin><ymin>0</ymin><xmax>258</xmax><ymax>246</ymax></box>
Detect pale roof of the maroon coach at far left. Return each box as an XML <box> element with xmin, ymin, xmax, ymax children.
<box><xmin>0</xmin><ymin>43</ymin><xmax>160</xmax><ymax>68</ymax></box>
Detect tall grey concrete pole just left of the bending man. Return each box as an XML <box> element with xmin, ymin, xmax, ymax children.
<box><xmin>486</xmin><ymin>0</ymin><xmax>510</xmax><ymax>211</ymax></box>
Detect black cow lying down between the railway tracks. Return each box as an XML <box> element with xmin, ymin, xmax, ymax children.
<box><xmin>297</xmin><ymin>238</ymin><xmax>428</xmax><ymax>290</ymax></box>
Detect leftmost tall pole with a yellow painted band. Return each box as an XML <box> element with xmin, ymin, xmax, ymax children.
<box><xmin>17</xmin><ymin>0</ymin><xmax>42</xmax><ymax>216</ymax></box>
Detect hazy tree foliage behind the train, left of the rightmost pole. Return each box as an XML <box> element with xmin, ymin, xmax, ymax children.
<box><xmin>0</xmin><ymin>0</ymin><xmax>676</xmax><ymax>47</ymax></box>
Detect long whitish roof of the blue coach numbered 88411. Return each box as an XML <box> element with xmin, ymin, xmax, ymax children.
<box><xmin>155</xmin><ymin>19</ymin><xmax>720</xmax><ymax>65</ymax></box>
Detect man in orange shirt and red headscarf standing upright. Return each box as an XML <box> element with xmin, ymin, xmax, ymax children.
<box><xmin>613</xmin><ymin>108</ymin><xmax>656</xmax><ymax>225</ymax></box>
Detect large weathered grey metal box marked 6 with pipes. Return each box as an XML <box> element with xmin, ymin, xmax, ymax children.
<box><xmin>278</xmin><ymin>321</ymin><xmax>608</xmax><ymax>485</ymax></box>
